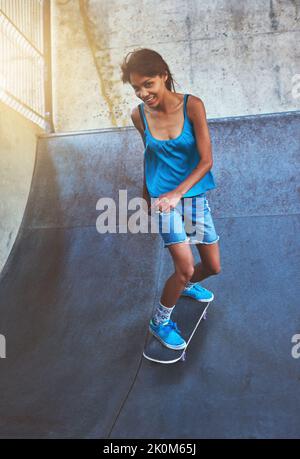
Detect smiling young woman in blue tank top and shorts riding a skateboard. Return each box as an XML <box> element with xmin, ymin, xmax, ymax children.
<box><xmin>121</xmin><ymin>48</ymin><xmax>221</xmax><ymax>349</ymax></box>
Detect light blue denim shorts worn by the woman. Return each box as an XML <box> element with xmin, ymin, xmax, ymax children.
<box><xmin>158</xmin><ymin>193</ymin><xmax>219</xmax><ymax>252</ymax></box>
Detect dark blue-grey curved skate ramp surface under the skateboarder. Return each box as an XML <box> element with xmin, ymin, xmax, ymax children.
<box><xmin>0</xmin><ymin>112</ymin><xmax>300</xmax><ymax>438</ymax></box>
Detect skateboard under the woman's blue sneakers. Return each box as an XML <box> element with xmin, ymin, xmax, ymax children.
<box><xmin>143</xmin><ymin>299</ymin><xmax>211</xmax><ymax>363</ymax></box>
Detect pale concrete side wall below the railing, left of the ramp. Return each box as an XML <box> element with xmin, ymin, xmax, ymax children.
<box><xmin>0</xmin><ymin>103</ymin><xmax>42</xmax><ymax>271</ymax></box>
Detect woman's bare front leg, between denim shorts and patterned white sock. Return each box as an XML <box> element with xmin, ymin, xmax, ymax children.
<box><xmin>160</xmin><ymin>242</ymin><xmax>194</xmax><ymax>308</ymax></box>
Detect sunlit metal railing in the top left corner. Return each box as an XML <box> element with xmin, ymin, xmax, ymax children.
<box><xmin>0</xmin><ymin>0</ymin><xmax>53</xmax><ymax>132</ymax></box>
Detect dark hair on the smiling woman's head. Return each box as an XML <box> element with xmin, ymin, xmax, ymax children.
<box><xmin>121</xmin><ymin>48</ymin><xmax>176</xmax><ymax>92</ymax></box>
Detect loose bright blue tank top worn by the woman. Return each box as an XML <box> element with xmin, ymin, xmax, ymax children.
<box><xmin>140</xmin><ymin>94</ymin><xmax>216</xmax><ymax>198</ymax></box>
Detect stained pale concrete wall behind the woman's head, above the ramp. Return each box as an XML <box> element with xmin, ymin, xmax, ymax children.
<box><xmin>52</xmin><ymin>0</ymin><xmax>300</xmax><ymax>131</ymax></box>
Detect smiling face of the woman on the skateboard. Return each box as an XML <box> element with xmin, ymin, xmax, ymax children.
<box><xmin>130</xmin><ymin>72</ymin><xmax>168</xmax><ymax>107</ymax></box>
